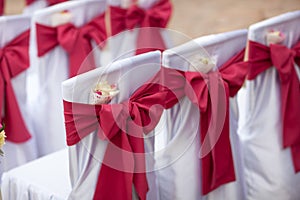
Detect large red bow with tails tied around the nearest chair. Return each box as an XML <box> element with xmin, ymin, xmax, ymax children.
<box><xmin>64</xmin><ymin>68</ymin><xmax>185</xmax><ymax>200</ymax></box>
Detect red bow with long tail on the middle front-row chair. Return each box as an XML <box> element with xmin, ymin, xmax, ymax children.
<box><xmin>186</xmin><ymin>50</ymin><xmax>248</xmax><ymax>195</ymax></box>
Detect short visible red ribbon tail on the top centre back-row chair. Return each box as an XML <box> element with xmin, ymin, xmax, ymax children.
<box><xmin>136</xmin><ymin>27</ymin><xmax>166</xmax><ymax>55</ymax></box>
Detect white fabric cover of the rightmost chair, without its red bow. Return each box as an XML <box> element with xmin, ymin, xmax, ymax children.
<box><xmin>238</xmin><ymin>11</ymin><xmax>300</xmax><ymax>200</ymax></box>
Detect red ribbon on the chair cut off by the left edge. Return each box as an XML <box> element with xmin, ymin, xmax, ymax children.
<box><xmin>0</xmin><ymin>31</ymin><xmax>31</xmax><ymax>143</ymax></box>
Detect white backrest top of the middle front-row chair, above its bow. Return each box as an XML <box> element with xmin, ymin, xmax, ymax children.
<box><xmin>163</xmin><ymin>29</ymin><xmax>247</xmax><ymax>71</ymax></box>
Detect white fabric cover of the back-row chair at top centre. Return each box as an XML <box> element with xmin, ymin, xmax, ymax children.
<box><xmin>108</xmin><ymin>0</ymin><xmax>172</xmax><ymax>60</ymax></box>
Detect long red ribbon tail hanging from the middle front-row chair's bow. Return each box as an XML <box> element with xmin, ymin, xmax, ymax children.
<box><xmin>201</xmin><ymin>74</ymin><xmax>235</xmax><ymax>195</ymax></box>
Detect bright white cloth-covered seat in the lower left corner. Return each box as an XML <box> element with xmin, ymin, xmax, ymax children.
<box><xmin>1</xmin><ymin>149</ymin><xmax>71</xmax><ymax>200</ymax></box>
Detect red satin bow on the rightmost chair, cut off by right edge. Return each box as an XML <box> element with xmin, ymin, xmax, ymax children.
<box><xmin>248</xmin><ymin>41</ymin><xmax>300</xmax><ymax>172</ymax></box>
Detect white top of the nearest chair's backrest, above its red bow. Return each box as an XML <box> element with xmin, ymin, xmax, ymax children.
<box><xmin>62</xmin><ymin>51</ymin><xmax>161</xmax><ymax>103</ymax></box>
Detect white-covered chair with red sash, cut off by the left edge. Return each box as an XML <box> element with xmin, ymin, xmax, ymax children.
<box><xmin>0</xmin><ymin>16</ymin><xmax>38</xmax><ymax>178</ymax></box>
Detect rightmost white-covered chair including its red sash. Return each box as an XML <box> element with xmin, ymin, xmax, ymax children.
<box><xmin>238</xmin><ymin>11</ymin><xmax>300</xmax><ymax>200</ymax></box>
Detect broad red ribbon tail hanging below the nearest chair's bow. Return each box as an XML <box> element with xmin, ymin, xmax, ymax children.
<box><xmin>93</xmin><ymin>132</ymin><xmax>134</xmax><ymax>200</ymax></box>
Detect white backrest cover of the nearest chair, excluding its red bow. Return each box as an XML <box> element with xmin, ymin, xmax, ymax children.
<box><xmin>62</xmin><ymin>51</ymin><xmax>161</xmax><ymax>199</ymax></box>
